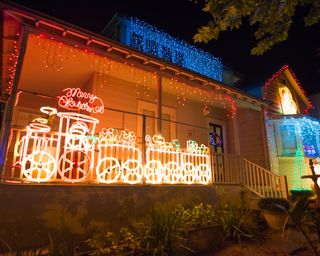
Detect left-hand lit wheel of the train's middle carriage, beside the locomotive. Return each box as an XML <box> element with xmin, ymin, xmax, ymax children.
<box><xmin>96</xmin><ymin>157</ymin><xmax>121</xmax><ymax>184</ymax></box>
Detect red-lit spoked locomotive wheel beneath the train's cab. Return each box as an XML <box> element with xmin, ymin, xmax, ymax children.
<box><xmin>58</xmin><ymin>150</ymin><xmax>90</xmax><ymax>182</ymax></box>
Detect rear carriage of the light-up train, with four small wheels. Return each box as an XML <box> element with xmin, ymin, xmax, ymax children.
<box><xmin>145</xmin><ymin>135</ymin><xmax>211</xmax><ymax>184</ymax></box>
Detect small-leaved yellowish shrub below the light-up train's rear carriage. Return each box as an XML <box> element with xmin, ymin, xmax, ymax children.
<box><xmin>174</xmin><ymin>203</ymin><xmax>215</xmax><ymax>230</ymax></box>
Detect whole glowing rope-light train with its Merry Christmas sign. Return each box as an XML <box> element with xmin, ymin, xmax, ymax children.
<box><xmin>14</xmin><ymin>88</ymin><xmax>212</xmax><ymax>184</ymax></box>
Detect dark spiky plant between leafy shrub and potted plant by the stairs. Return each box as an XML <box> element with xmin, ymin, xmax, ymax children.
<box><xmin>216</xmin><ymin>205</ymin><xmax>257</xmax><ymax>242</ymax></box>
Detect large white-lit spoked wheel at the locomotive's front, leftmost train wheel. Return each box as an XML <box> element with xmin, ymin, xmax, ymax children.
<box><xmin>21</xmin><ymin>151</ymin><xmax>57</xmax><ymax>182</ymax></box>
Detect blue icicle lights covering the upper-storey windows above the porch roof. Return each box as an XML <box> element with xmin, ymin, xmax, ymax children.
<box><xmin>120</xmin><ymin>18</ymin><xmax>223</xmax><ymax>81</ymax></box>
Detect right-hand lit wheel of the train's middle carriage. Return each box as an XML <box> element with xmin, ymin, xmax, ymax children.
<box><xmin>122</xmin><ymin>159</ymin><xmax>143</xmax><ymax>184</ymax></box>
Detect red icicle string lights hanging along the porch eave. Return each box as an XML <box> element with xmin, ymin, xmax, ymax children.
<box><xmin>31</xmin><ymin>34</ymin><xmax>236</xmax><ymax>115</ymax></box>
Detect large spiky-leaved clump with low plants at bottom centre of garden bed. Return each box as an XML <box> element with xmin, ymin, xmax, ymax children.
<box><xmin>86</xmin><ymin>208</ymin><xmax>187</xmax><ymax>256</ymax></box>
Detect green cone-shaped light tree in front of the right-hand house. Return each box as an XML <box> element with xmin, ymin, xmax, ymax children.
<box><xmin>292</xmin><ymin>145</ymin><xmax>310</xmax><ymax>191</ymax></box>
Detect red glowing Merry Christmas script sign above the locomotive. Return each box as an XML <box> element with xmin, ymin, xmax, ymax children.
<box><xmin>58</xmin><ymin>88</ymin><xmax>104</xmax><ymax>113</ymax></box>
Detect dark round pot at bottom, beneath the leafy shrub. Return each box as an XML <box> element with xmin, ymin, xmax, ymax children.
<box><xmin>186</xmin><ymin>224</ymin><xmax>223</xmax><ymax>255</ymax></box>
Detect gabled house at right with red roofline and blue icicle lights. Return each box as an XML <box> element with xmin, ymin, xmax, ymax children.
<box><xmin>248</xmin><ymin>65</ymin><xmax>320</xmax><ymax>193</ymax></box>
